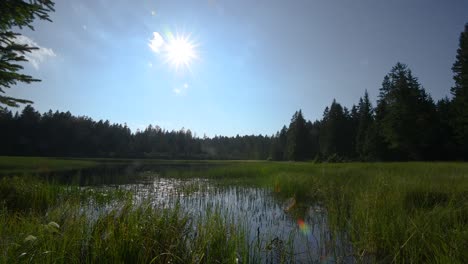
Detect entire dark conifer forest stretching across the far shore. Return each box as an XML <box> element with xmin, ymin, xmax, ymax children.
<box><xmin>0</xmin><ymin>24</ymin><xmax>468</xmax><ymax>162</ymax></box>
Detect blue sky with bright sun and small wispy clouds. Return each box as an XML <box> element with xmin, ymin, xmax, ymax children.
<box><xmin>8</xmin><ymin>0</ymin><xmax>468</xmax><ymax>137</ymax></box>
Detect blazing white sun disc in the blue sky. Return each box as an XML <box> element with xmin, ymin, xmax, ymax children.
<box><xmin>165</xmin><ymin>35</ymin><xmax>198</xmax><ymax>70</ymax></box>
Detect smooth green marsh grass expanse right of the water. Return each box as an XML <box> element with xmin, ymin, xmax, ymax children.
<box><xmin>161</xmin><ymin>162</ymin><xmax>468</xmax><ymax>263</ymax></box>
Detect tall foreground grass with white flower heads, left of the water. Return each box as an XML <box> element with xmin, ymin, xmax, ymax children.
<box><xmin>0</xmin><ymin>178</ymin><xmax>248</xmax><ymax>263</ymax></box>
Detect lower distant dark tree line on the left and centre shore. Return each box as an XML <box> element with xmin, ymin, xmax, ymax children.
<box><xmin>0</xmin><ymin>105</ymin><xmax>271</xmax><ymax>159</ymax></box>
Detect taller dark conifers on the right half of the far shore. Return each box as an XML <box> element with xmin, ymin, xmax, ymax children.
<box><xmin>271</xmin><ymin>24</ymin><xmax>468</xmax><ymax>162</ymax></box>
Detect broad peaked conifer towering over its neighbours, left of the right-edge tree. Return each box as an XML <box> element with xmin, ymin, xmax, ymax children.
<box><xmin>377</xmin><ymin>63</ymin><xmax>436</xmax><ymax>160</ymax></box>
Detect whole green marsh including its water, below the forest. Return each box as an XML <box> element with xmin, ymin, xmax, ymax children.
<box><xmin>0</xmin><ymin>157</ymin><xmax>468</xmax><ymax>263</ymax></box>
